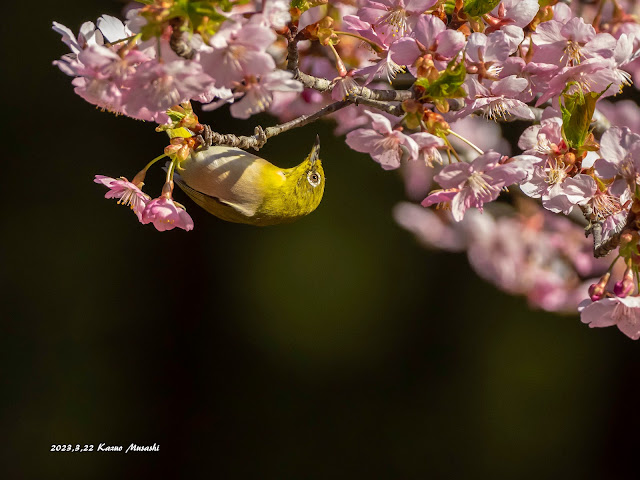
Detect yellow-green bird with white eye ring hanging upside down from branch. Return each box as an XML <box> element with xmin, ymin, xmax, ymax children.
<box><xmin>174</xmin><ymin>135</ymin><xmax>325</xmax><ymax>226</ymax></box>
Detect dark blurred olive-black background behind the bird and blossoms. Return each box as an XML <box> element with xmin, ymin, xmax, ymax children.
<box><xmin>0</xmin><ymin>0</ymin><xmax>640</xmax><ymax>479</ymax></box>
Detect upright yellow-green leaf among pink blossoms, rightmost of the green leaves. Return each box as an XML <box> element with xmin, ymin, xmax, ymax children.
<box><xmin>560</xmin><ymin>82</ymin><xmax>609</xmax><ymax>149</ymax></box>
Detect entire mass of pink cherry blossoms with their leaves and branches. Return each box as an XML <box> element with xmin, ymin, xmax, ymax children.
<box><xmin>54</xmin><ymin>0</ymin><xmax>640</xmax><ymax>339</ymax></box>
